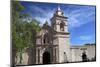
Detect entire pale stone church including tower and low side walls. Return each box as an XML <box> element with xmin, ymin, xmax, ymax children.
<box><xmin>16</xmin><ymin>7</ymin><xmax>95</xmax><ymax>65</ymax></box>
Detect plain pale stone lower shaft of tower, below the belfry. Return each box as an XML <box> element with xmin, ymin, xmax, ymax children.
<box><xmin>58</xmin><ymin>35</ymin><xmax>70</xmax><ymax>63</ymax></box>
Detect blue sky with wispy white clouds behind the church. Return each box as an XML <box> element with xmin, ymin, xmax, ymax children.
<box><xmin>21</xmin><ymin>2</ymin><xmax>96</xmax><ymax>46</ymax></box>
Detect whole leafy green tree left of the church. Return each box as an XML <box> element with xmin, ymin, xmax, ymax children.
<box><xmin>11</xmin><ymin>1</ymin><xmax>40</xmax><ymax>65</ymax></box>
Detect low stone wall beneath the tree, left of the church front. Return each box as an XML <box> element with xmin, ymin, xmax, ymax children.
<box><xmin>15</xmin><ymin>48</ymin><xmax>36</xmax><ymax>65</ymax></box>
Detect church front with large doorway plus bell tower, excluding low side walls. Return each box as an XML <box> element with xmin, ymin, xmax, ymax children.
<box><xmin>36</xmin><ymin>7</ymin><xmax>70</xmax><ymax>64</ymax></box>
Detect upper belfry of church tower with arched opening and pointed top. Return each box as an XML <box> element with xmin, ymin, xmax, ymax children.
<box><xmin>51</xmin><ymin>6</ymin><xmax>68</xmax><ymax>32</ymax></box>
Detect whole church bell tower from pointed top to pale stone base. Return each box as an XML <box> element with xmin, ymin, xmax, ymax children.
<box><xmin>51</xmin><ymin>6</ymin><xmax>70</xmax><ymax>63</ymax></box>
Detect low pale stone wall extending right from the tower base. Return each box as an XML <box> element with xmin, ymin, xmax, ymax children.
<box><xmin>70</xmin><ymin>45</ymin><xmax>96</xmax><ymax>62</ymax></box>
